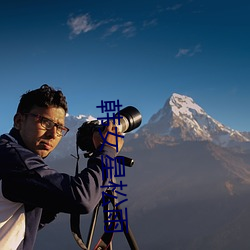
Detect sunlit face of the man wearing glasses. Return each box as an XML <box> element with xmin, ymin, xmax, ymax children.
<box><xmin>14</xmin><ymin>106</ymin><xmax>66</xmax><ymax>158</ymax></box>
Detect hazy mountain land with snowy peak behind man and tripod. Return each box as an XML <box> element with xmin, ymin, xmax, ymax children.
<box><xmin>36</xmin><ymin>94</ymin><xmax>250</xmax><ymax>250</ymax></box>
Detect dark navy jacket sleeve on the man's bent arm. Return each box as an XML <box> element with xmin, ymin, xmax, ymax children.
<box><xmin>1</xmin><ymin>140</ymin><xmax>116</xmax><ymax>213</ymax></box>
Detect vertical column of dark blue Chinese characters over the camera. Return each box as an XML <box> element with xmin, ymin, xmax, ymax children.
<box><xmin>96</xmin><ymin>100</ymin><xmax>128</xmax><ymax>232</ymax></box>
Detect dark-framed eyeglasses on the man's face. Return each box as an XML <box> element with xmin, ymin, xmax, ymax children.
<box><xmin>24</xmin><ymin>113</ymin><xmax>69</xmax><ymax>136</ymax></box>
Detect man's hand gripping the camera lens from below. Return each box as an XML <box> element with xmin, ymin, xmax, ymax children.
<box><xmin>93</xmin><ymin>122</ymin><xmax>124</xmax><ymax>154</ymax></box>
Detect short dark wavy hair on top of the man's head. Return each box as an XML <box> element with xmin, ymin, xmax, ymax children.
<box><xmin>17</xmin><ymin>84</ymin><xmax>68</xmax><ymax>114</ymax></box>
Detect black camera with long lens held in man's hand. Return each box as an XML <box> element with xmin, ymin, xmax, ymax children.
<box><xmin>76</xmin><ymin>106</ymin><xmax>142</xmax><ymax>153</ymax></box>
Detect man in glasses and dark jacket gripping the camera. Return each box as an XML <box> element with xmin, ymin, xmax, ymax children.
<box><xmin>0</xmin><ymin>85</ymin><xmax>123</xmax><ymax>250</ymax></box>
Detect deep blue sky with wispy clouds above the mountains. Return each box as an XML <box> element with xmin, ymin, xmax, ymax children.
<box><xmin>0</xmin><ymin>0</ymin><xmax>250</xmax><ymax>133</ymax></box>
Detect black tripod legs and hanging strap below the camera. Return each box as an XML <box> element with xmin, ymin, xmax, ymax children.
<box><xmin>70</xmin><ymin>190</ymin><xmax>139</xmax><ymax>250</ymax></box>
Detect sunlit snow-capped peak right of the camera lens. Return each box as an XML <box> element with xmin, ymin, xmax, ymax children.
<box><xmin>140</xmin><ymin>93</ymin><xmax>250</xmax><ymax>146</ymax></box>
